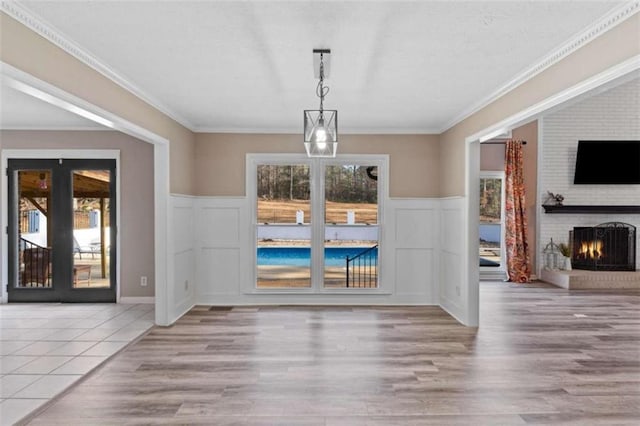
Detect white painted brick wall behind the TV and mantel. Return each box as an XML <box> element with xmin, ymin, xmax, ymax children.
<box><xmin>538</xmin><ymin>79</ymin><xmax>640</xmax><ymax>270</ymax></box>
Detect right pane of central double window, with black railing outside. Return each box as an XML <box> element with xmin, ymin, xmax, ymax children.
<box><xmin>324</xmin><ymin>164</ymin><xmax>378</xmax><ymax>288</ymax></box>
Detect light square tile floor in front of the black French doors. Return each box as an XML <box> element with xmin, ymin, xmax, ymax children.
<box><xmin>0</xmin><ymin>304</ymin><xmax>154</xmax><ymax>426</ymax></box>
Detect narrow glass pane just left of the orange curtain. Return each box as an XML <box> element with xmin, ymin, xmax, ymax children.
<box><xmin>479</xmin><ymin>177</ymin><xmax>503</xmax><ymax>270</ymax></box>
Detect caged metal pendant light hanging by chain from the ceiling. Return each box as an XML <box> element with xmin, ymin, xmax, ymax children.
<box><xmin>304</xmin><ymin>49</ymin><xmax>338</xmax><ymax>157</ymax></box>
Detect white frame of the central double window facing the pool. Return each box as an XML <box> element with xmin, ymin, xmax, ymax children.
<box><xmin>245</xmin><ymin>154</ymin><xmax>391</xmax><ymax>295</ymax></box>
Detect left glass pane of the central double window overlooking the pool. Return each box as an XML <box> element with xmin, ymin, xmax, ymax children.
<box><xmin>256</xmin><ymin>164</ymin><xmax>311</xmax><ymax>288</ymax></box>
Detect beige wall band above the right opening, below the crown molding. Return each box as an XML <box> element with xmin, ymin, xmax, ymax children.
<box><xmin>440</xmin><ymin>14</ymin><xmax>640</xmax><ymax>196</ymax></box>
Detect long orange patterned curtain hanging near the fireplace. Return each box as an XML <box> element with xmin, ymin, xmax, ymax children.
<box><xmin>505</xmin><ymin>140</ymin><xmax>531</xmax><ymax>283</ymax></box>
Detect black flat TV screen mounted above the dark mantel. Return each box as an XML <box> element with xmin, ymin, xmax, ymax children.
<box><xmin>573</xmin><ymin>141</ymin><xmax>640</xmax><ymax>185</ymax></box>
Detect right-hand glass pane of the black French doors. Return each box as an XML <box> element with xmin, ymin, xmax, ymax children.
<box><xmin>72</xmin><ymin>170</ymin><xmax>111</xmax><ymax>289</ymax></box>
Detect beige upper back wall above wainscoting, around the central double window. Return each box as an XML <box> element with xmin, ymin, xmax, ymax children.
<box><xmin>195</xmin><ymin>133</ymin><xmax>440</xmax><ymax>197</ymax></box>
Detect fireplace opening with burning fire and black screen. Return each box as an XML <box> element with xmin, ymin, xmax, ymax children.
<box><xmin>569</xmin><ymin>222</ymin><xmax>636</xmax><ymax>271</ymax></box>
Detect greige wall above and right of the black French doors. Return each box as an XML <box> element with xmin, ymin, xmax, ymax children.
<box><xmin>0</xmin><ymin>130</ymin><xmax>155</xmax><ymax>297</ymax></box>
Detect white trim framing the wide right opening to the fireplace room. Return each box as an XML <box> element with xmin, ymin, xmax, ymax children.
<box><xmin>462</xmin><ymin>55</ymin><xmax>640</xmax><ymax>325</ymax></box>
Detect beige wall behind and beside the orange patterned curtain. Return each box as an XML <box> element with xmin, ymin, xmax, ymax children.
<box><xmin>480</xmin><ymin>120</ymin><xmax>538</xmax><ymax>271</ymax></box>
